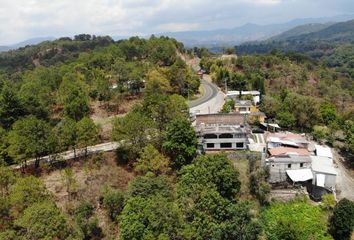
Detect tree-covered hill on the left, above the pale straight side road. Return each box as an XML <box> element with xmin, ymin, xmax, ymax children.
<box><xmin>0</xmin><ymin>34</ymin><xmax>199</xmax><ymax>167</ymax></box>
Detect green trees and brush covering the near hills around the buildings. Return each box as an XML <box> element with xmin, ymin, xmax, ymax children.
<box><xmin>0</xmin><ymin>32</ymin><xmax>354</xmax><ymax>240</ymax></box>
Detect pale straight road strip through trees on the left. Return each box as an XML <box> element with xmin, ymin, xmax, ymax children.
<box><xmin>12</xmin><ymin>142</ymin><xmax>119</xmax><ymax>169</ymax></box>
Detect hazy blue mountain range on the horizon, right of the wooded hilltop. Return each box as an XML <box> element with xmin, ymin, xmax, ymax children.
<box><xmin>156</xmin><ymin>14</ymin><xmax>354</xmax><ymax>47</ymax></box>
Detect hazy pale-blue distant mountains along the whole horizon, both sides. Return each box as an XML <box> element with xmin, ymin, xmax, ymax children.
<box><xmin>0</xmin><ymin>14</ymin><xmax>354</xmax><ymax>52</ymax></box>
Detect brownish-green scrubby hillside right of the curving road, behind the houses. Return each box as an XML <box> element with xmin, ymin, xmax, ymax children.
<box><xmin>201</xmin><ymin>52</ymin><xmax>354</xmax><ymax>164</ymax></box>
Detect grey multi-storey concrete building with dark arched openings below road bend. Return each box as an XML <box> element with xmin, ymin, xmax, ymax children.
<box><xmin>195</xmin><ymin>114</ymin><xmax>251</xmax><ymax>151</ymax></box>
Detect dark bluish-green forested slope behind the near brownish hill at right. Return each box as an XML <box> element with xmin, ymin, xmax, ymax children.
<box><xmin>236</xmin><ymin>20</ymin><xmax>354</xmax><ymax>78</ymax></box>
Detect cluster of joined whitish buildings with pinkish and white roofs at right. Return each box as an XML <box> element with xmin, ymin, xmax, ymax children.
<box><xmin>265</xmin><ymin>132</ymin><xmax>337</xmax><ymax>198</ymax></box>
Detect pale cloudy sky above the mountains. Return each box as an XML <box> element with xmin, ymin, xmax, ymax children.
<box><xmin>0</xmin><ymin>0</ymin><xmax>354</xmax><ymax>45</ymax></box>
